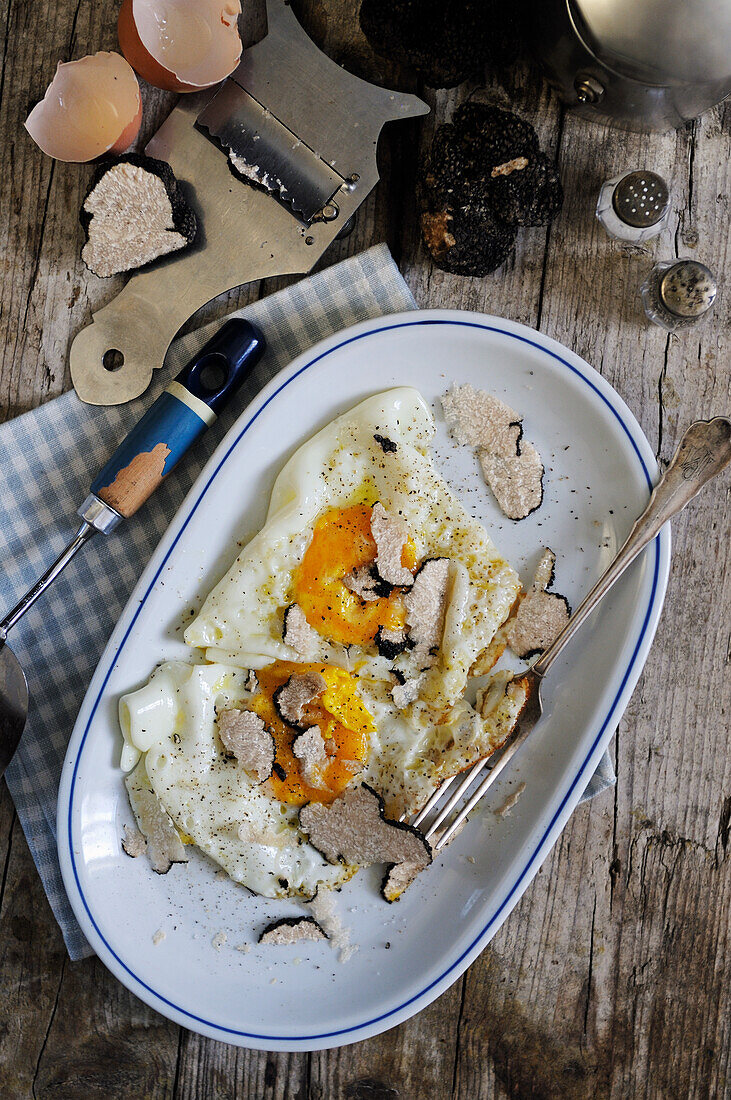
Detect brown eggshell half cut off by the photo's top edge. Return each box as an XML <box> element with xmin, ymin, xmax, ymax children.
<box><xmin>117</xmin><ymin>0</ymin><xmax>241</xmax><ymax>91</ymax></box>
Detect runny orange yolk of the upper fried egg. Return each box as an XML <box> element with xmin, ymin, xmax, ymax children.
<box><xmin>295</xmin><ymin>504</ymin><xmax>416</xmax><ymax>646</ymax></box>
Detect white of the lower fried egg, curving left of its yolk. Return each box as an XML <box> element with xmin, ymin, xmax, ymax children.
<box><xmin>120</xmin><ymin>661</ymin><xmax>353</xmax><ymax>898</ymax></box>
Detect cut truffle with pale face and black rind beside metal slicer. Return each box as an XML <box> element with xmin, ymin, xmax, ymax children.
<box><xmin>80</xmin><ymin>154</ymin><xmax>198</xmax><ymax>278</ymax></box>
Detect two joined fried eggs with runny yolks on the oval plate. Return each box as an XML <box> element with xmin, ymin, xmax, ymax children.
<box><xmin>120</xmin><ymin>388</ymin><xmax>525</xmax><ymax>898</ymax></box>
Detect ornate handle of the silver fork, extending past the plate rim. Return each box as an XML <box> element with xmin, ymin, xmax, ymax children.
<box><xmin>532</xmin><ymin>416</ymin><xmax>731</xmax><ymax>677</ymax></box>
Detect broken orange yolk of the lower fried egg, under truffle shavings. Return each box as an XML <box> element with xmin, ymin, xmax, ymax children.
<box><xmin>250</xmin><ymin>661</ymin><xmax>375</xmax><ymax>806</ymax></box>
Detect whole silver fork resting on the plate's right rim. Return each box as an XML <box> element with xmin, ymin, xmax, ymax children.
<box><xmin>411</xmin><ymin>416</ymin><xmax>731</xmax><ymax>850</ymax></box>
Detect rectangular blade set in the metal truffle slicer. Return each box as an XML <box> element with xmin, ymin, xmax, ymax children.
<box><xmin>197</xmin><ymin>80</ymin><xmax>345</xmax><ymax>223</ymax></box>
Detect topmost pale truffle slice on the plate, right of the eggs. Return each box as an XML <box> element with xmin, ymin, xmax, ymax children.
<box><xmin>441</xmin><ymin>383</ymin><xmax>522</xmax><ymax>457</ymax></box>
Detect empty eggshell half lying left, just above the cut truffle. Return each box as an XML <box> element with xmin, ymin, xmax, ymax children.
<box><xmin>25</xmin><ymin>51</ymin><xmax>142</xmax><ymax>163</ymax></box>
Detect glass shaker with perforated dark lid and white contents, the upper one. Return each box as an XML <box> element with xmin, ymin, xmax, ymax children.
<box><xmin>597</xmin><ymin>169</ymin><xmax>671</xmax><ymax>244</ymax></box>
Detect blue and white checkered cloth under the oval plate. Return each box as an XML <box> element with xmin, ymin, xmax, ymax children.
<box><xmin>0</xmin><ymin>245</ymin><xmax>614</xmax><ymax>959</ymax></box>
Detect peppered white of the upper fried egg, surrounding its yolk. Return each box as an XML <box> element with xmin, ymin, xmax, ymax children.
<box><xmin>185</xmin><ymin>387</ymin><xmax>520</xmax><ymax>707</ymax></box>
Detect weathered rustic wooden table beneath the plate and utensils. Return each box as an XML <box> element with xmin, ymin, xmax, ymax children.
<box><xmin>0</xmin><ymin>0</ymin><xmax>731</xmax><ymax>1100</ymax></box>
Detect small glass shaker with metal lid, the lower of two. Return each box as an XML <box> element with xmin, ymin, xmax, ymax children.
<box><xmin>640</xmin><ymin>260</ymin><xmax>718</xmax><ymax>332</ymax></box>
